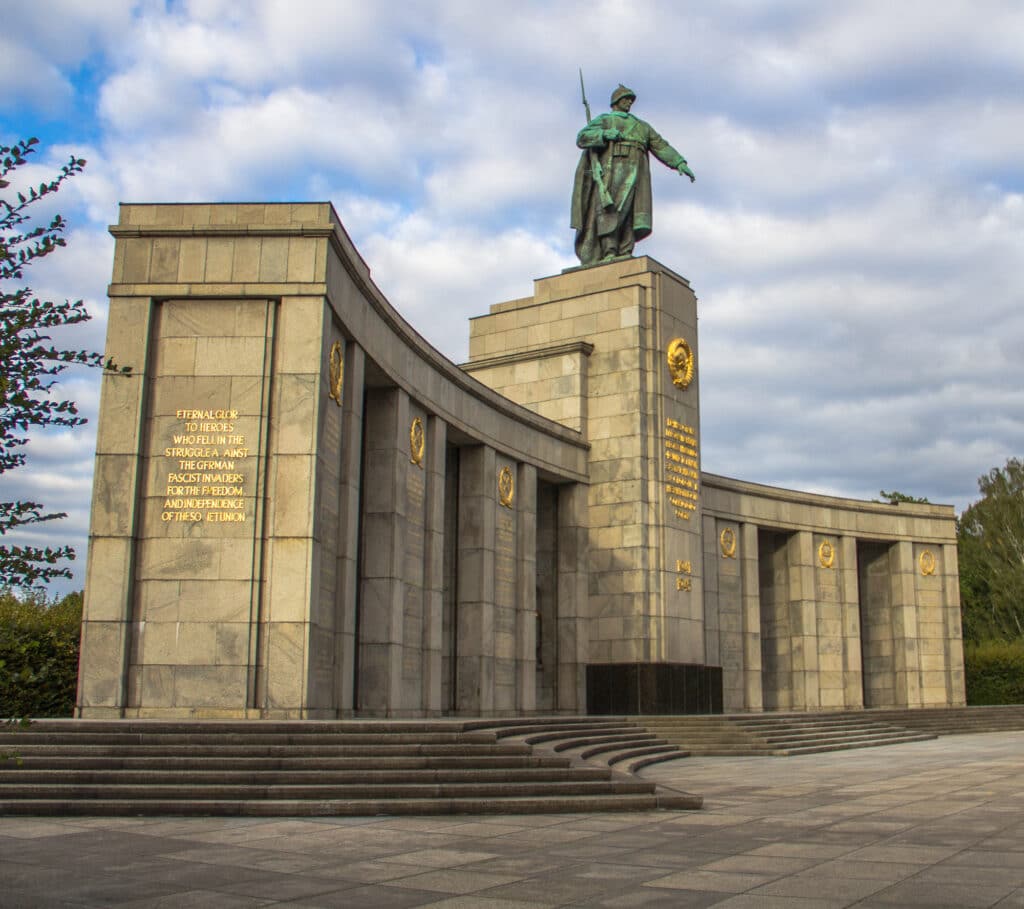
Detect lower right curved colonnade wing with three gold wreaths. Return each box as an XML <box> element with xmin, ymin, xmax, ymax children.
<box><xmin>702</xmin><ymin>474</ymin><xmax>965</xmax><ymax>710</ymax></box>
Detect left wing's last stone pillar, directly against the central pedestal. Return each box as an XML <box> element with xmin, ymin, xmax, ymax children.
<box><xmin>557</xmin><ymin>483</ymin><xmax>590</xmax><ymax>712</ymax></box>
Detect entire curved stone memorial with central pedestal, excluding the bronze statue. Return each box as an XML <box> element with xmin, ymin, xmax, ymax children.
<box><xmin>78</xmin><ymin>204</ymin><xmax>964</xmax><ymax>718</ymax></box>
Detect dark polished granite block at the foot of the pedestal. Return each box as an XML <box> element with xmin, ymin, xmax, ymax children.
<box><xmin>587</xmin><ymin>663</ymin><xmax>722</xmax><ymax>716</ymax></box>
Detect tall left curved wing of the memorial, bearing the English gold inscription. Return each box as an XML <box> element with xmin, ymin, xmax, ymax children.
<box><xmin>78</xmin><ymin>204</ymin><xmax>587</xmax><ymax>718</ymax></box>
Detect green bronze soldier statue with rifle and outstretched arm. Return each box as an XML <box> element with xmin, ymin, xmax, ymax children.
<box><xmin>571</xmin><ymin>84</ymin><xmax>696</xmax><ymax>265</ymax></box>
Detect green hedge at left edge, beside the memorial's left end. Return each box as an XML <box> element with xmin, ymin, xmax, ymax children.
<box><xmin>0</xmin><ymin>591</ymin><xmax>82</xmax><ymax>718</ymax></box>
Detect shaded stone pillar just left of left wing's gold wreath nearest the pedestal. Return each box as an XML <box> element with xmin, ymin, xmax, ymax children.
<box><xmin>456</xmin><ymin>445</ymin><xmax>498</xmax><ymax>716</ymax></box>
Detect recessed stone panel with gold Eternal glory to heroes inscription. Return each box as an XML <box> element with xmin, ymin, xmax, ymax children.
<box><xmin>138</xmin><ymin>300</ymin><xmax>278</xmax><ymax>712</ymax></box>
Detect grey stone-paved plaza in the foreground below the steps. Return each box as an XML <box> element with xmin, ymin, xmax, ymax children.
<box><xmin>0</xmin><ymin>732</ymin><xmax>1024</xmax><ymax>909</ymax></box>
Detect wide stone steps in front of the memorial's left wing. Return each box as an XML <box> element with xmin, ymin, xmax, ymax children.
<box><xmin>0</xmin><ymin>720</ymin><xmax>700</xmax><ymax>817</ymax></box>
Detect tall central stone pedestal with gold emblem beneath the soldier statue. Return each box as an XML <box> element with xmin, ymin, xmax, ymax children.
<box><xmin>464</xmin><ymin>257</ymin><xmax>721</xmax><ymax>703</ymax></box>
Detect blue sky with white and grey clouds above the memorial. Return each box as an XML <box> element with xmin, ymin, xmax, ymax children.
<box><xmin>0</xmin><ymin>0</ymin><xmax>1024</xmax><ymax>585</ymax></box>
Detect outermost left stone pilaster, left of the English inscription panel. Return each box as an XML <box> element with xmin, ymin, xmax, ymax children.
<box><xmin>76</xmin><ymin>297</ymin><xmax>153</xmax><ymax>718</ymax></box>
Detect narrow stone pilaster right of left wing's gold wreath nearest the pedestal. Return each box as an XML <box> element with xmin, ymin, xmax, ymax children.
<box><xmin>515</xmin><ymin>464</ymin><xmax>537</xmax><ymax>713</ymax></box>
